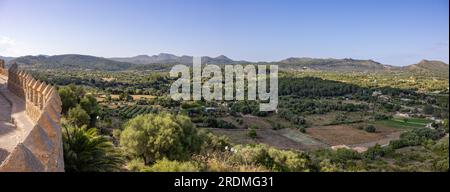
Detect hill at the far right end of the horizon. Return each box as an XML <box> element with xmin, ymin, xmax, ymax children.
<box><xmin>404</xmin><ymin>60</ymin><xmax>449</xmax><ymax>77</ymax></box>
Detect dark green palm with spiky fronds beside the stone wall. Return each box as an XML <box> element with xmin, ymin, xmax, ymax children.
<box><xmin>63</xmin><ymin>125</ymin><xmax>124</xmax><ymax>172</ymax></box>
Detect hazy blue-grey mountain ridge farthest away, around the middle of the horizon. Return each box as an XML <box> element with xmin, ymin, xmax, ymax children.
<box><xmin>109</xmin><ymin>53</ymin><xmax>244</xmax><ymax>65</ymax></box>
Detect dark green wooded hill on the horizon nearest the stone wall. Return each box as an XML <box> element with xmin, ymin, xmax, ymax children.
<box><xmin>10</xmin><ymin>54</ymin><xmax>132</xmax><ymax>71</ymax></box>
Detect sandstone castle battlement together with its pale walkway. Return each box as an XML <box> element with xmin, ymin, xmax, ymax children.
<box><xmin>0</xmin><ymin>60</ymin><xmax>64</xmax><ymax>171</ymax></box>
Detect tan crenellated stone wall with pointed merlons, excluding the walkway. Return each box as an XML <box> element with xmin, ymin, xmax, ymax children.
<box><xmin>0</xmin><ymin>64</ymin><xmax>64</xmax><ymax>172</ymax></box>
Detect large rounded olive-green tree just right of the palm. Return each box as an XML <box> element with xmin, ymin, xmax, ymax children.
<box><xmin>120</xmin><ymin>113</ymin><xmax>203</xmax><ymax>165</ymax></box>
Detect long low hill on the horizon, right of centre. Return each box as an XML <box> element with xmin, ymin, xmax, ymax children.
<box><xmin>279</xmin><ymin>57</ymin><xmax>388</xmax><ymax>71</ymax></box>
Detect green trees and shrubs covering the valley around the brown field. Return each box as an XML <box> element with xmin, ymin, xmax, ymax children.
<box><xmin>27</xmin><ymin>65</ymin><xmax>449</xmax><ymax>172</ymax></box>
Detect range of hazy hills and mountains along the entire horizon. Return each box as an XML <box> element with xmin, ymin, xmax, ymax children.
<box><xmin>0</xmin><ymin>53</ymin><xmax>449</xmax><ymax>77</ymax></box>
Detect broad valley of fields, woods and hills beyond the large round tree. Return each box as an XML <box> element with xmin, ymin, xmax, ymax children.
<box><xmin>1</xmin><ymin>54</ymin><xmax>449</xmax><ymax>171</ymax></box>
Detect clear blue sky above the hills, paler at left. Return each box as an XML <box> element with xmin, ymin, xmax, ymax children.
<box><xmin>0</xmin><ymin>0</ymin><xmax>449</xmax><ymax>65</ymax></box>
